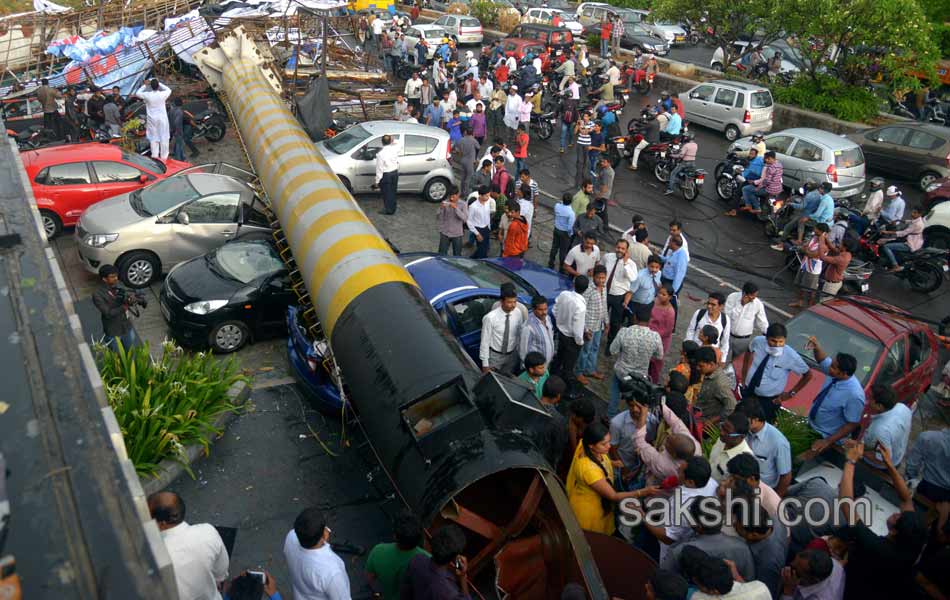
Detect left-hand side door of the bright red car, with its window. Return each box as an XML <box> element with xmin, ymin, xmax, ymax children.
<box><xmin>33</xmin><ymin>162</ymin><xmax>97</xmax><ymax>225</ymax></box>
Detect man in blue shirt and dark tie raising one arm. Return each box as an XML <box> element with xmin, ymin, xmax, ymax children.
<box><xmin>808</xmin><ymin>336</ymin><xmax>864</xmax><ymax>453</ymax></box>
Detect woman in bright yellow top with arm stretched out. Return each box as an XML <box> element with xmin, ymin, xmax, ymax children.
<box><xmin>565</xmin><ymin>421</ymin><xmax>657</xmax><ymax>535</ymax></box>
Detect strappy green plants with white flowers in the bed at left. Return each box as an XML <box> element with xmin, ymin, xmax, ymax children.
<box><xmin>95</xmin><ymin>342</ymin><xmax>245</xmax><ymax>477</ymax></box>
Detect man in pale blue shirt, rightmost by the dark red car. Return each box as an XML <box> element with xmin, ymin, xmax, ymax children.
<box><xmin>864</xmin><ymin>383</ymin><xmax>911</xmax><ymax>469</ymax></box>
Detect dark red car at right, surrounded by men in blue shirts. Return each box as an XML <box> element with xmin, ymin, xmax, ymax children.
<box><xmin>733</xmin><ymin>296</ymin><xmax>937</xmax><ymax>417</ymax></box>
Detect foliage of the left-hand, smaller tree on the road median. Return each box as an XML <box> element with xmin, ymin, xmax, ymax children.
<box><xmin>653</xmin><ymin>0</ymin><xmax>788</xmax><ymax>66</ymax></box>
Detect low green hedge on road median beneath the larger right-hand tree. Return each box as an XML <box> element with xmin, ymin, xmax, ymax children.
<box><xmin>772</xmin><ymin>76</ymin><xmax>879</xmax><ymax>122</ymax></box>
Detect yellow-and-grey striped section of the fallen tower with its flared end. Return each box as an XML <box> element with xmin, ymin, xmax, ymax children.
<box><xmin>195</xmin><ymin>27</ymin><xmax>416</xmax><ymax>340</ymax></box>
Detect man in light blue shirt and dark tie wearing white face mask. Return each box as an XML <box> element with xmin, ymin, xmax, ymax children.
<box><xmin>739</xmin><ymin>323</ymin><xmax>811</xmax><ymax>423</ymax></box>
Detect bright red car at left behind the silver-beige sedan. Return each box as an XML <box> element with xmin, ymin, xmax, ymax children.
<box><xmin>20</xmin><ymin>142</ymin><xmax>191</xmax><ymax>238</ymax></box>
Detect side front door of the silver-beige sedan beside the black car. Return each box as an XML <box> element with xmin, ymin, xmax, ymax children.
<box><xmin>172</xmin><ymin>192</ymin><xmax>241</xmax><ymax>266</ymax></box>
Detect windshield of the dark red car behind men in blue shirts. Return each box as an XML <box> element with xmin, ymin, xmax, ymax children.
<box><xmin>786</xmin><ymin>312</ymin><xmax>884</xmax><ymax>385</ymax></box>
